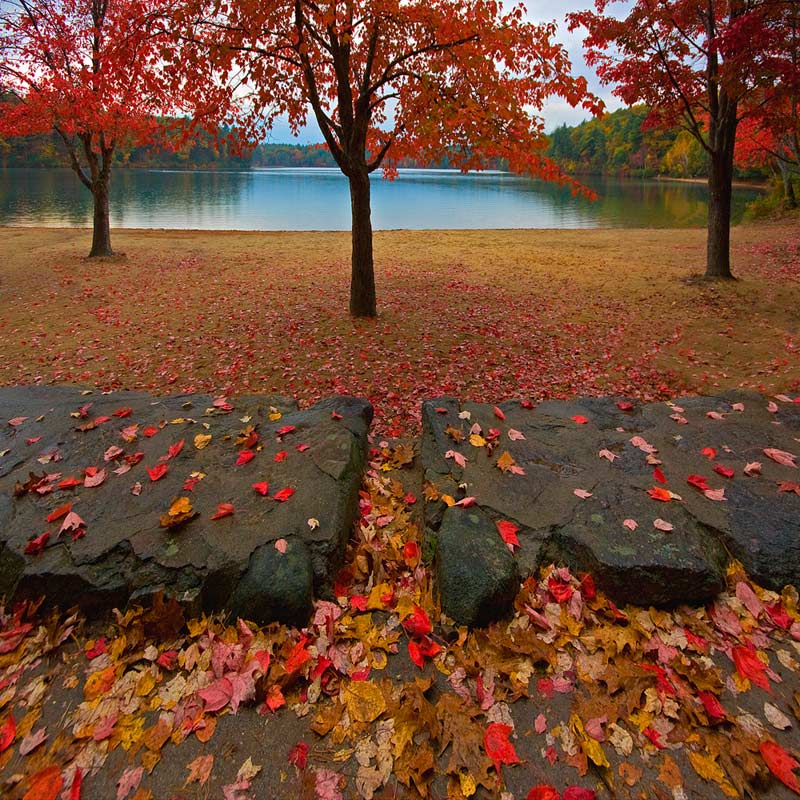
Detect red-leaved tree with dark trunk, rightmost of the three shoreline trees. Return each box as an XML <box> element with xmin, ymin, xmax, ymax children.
<box><xmin>570</xmin><ymin>0</ymin><xmax>796</xmax><ymax>279</ymax></box>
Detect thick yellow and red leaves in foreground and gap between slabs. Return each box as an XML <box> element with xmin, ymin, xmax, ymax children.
<box><xmin>0</xmin><ymin>446</ymin><xmax>800</xmax><ymax>800</ymax></box>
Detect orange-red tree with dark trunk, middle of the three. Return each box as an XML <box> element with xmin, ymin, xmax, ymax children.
<box><xmin>174</xmin><ymin>0</ymin><xmax>597</xmax><ymax>317</ymax></box>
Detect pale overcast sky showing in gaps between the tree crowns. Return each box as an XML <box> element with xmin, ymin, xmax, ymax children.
<box><xmin>268</xmin><ymin>0</ymin><xmax>622</xmax><ymax>144</ymax></box>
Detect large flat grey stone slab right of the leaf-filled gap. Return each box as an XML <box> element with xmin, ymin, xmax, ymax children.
<box><xmin>421</xmin><ymin>393</ymin><xmax>800</xmax><ymax>620</ymax></box>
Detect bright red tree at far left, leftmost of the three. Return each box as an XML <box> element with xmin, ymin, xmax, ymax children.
<box><xmin>0</xmin><ymin>0</ymin><xmax>186</xmax><ymax>257</ymax></box>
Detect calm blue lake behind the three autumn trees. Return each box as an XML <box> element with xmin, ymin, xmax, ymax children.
<box><xmin>0</xmin><ymin>168</ymin><xmax>759</xmax><ymax>230</ymax></box>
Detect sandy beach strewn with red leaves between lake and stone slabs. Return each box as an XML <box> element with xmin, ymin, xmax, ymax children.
<box><xmin>0</xmin><ymin>222</ymin><xmax>800</xmax><ymax>436</ymax></box>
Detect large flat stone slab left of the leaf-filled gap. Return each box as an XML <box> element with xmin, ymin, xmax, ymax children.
<box><xmin>0</xmin><ymin>387</ymin><xmax>372</xmax><ymax>622</ymax></box>
